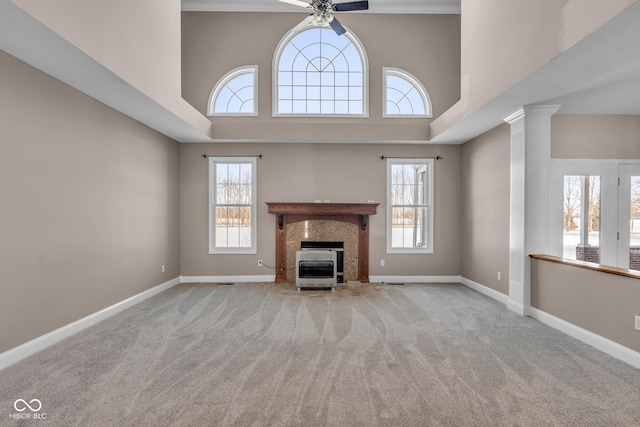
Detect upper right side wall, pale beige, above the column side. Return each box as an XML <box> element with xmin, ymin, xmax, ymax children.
<box><xmin>431</xmin><ymin>0</ymin><xmax>638</xmax><ymax>137</ymax></box>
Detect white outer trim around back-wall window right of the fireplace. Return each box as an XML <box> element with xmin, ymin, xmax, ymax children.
<box><xmin>386</xmin><ymin>158</ymin><xmax>435</xmax><ymax>254</ymax></box>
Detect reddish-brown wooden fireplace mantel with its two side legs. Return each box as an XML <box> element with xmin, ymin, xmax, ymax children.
<box><xmin>267</xmin><ymin>202</ymin><xmax>379</xmax><ymax>283</ymax></box>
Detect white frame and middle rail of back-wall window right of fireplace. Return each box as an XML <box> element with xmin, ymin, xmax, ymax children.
<box><xmin>386</xmin><ymin>157</ymin><xmax>435</xmax><ymax>254</ymax></box>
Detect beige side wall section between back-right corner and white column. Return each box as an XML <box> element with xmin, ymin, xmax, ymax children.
<box><xmin>460</xmin><ymin>124</ymin><xmax>511</xmax><ymax>294</ymax></box>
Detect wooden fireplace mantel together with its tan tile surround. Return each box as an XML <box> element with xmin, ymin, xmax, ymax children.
<box><xmin>267</xmin><ymin>202</ymin><xmax>379</xmax><ymax>283</ymax></box>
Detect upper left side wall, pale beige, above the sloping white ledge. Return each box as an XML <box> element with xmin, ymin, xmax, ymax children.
<box><xmin>14</xmin><ymin>0</ymin><xmax>210</xmax><ymax>134</ymax></box>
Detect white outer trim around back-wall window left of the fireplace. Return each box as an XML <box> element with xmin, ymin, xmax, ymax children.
<box><xmin>209</xmin><ymin>156</ymin><xmax>258</xmax><ymax>254</ymax></box>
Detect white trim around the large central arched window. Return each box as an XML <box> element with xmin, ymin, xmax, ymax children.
<box><xmin>271</xmin><ymin>23</ymin><xmax>369</xmax><ymax>119</ymax></box>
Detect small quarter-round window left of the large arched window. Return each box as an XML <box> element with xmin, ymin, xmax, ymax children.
<box><xmin>207</xmin><ymin>65</ymin><xmax>258</xmax><ymax>116</ymax></box>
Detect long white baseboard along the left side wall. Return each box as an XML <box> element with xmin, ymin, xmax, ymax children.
<box><xmin>0</xmin><ymin>277</ymin><xmax>180</xmax><ymax>370</ymax></box>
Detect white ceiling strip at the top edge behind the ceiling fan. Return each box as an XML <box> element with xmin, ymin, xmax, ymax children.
<box><xmin>182</xmin><ymin>0</ymin><xmax>460</xmax><ymax>14</ymax></box>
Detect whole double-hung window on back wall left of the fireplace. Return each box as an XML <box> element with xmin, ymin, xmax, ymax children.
<box><xmin>209</xmin><ymin>157</ymin><xmax>256</xmax><ymax>254</ymax></box>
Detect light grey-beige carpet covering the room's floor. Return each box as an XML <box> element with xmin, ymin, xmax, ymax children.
<box><xmin>0</xmin><ymin>284</ymin><xmax>640</xmax><ymax>426</ymax></box>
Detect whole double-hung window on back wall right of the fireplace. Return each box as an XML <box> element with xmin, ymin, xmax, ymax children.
<box><xmin>387</xmin><ymin>159</ymin><xmax>434</xmax><ymax>253</ymax></box>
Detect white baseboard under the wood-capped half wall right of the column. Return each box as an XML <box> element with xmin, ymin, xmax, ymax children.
<box><xmin>529</xmin><ymin>307</ymin><xmax>640</xmax><ymax>369</ymax></box>
